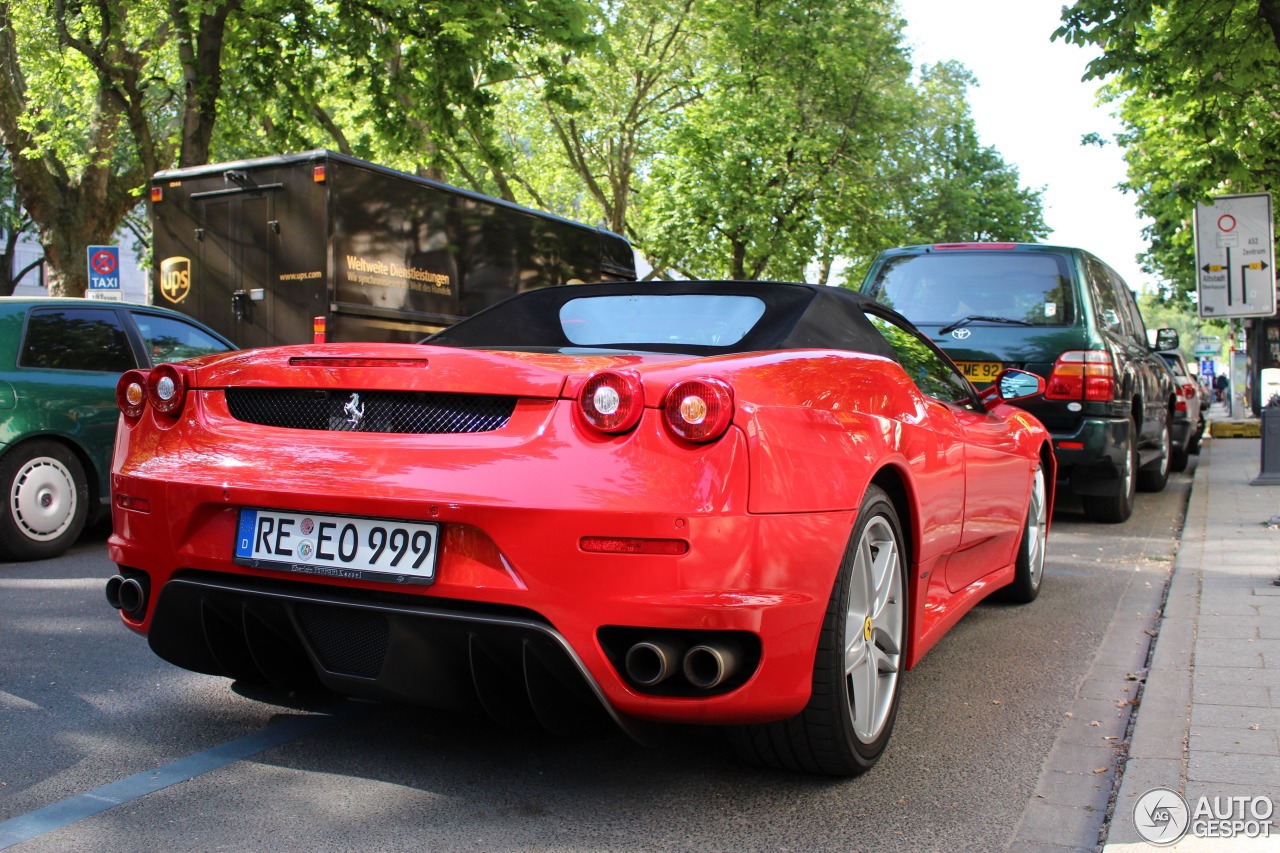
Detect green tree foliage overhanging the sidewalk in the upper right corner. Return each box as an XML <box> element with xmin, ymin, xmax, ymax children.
<box><xmin>1056</xmin><ymin>0</ymin><xmax>1280</xmax><ymax>306</ymax></box>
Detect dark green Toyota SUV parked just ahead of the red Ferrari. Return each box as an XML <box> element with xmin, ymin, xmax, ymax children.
<box><xmin>860</xmin><ymin>243</ymin><xmax>1178</xmax><ymax>521</ymax></box>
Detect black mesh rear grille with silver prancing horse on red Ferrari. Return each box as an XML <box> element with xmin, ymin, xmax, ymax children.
<box><xmin>227</xmin><ymin>388</ymin><xmax>516</xmax><ymax>434</ymax></box>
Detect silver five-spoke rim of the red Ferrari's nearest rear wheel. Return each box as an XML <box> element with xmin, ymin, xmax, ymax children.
<box><xmin>845</xmin><ymin>516</ymin><xmax>906</xmax><ymax>743</ymax></box>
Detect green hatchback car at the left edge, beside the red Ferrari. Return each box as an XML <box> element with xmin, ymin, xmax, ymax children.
<box><xmin>0</xmin><ymin>296</ymin><xmax>236</xmax><ymax>562</ymax></box>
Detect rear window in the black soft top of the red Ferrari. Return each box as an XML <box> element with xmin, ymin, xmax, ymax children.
<box><xmin>559</xmin><ymin>293</ymin><xmax>764</xmax><ymax>347</ymax></box>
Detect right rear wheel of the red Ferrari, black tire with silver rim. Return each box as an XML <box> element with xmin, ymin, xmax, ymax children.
<box><xmin>730</xmin><ymin>485</ymin><xmax>908</xmax><ymax>776</ymax></box>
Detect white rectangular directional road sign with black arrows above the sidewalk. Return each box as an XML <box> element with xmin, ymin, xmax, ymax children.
<box><xmin>1196</xmin><ymin>192</ymin><xmax>1276</xmax><ymax>318</ymax></box>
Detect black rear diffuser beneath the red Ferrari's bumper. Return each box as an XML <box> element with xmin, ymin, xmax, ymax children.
<box><xmin>148</xmin><ymin>573</ymin><xmax>644</xmax><ymax>739</ymax></box>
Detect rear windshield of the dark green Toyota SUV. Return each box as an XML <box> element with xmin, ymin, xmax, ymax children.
<box><xmin>865</xmin><ymin>251</ymin><xmax>1075</xmax><ymax>325</ymax></box>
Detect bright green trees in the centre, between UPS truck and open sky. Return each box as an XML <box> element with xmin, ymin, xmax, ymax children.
<box><xmin>491</xmin><ymin>0</ymin><xmax>1046</xmax><ymax>282</ymax></box>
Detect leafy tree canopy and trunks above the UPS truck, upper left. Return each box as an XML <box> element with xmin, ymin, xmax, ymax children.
<box><xmin>0</xmin><ymin>0</ymin><xmax>589</xmax><ymax>295</ymax></box>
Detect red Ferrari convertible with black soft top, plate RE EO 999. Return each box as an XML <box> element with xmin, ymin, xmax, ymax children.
<box><xmin>106</xmin><ymin>282</ymin><xmax>1055</xmax><ymax>775</ymax></box>
